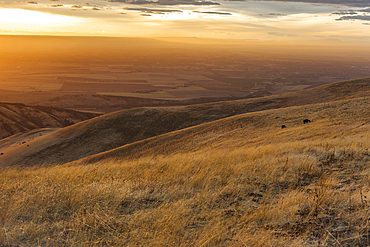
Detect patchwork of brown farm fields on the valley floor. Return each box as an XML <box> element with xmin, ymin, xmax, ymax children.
<box><xmin>0</xmin><ymin>66</ymin><xmax>249</xmax><ymax>103</ymax></box>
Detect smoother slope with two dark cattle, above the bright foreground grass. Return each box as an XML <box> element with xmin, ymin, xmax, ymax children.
<box><xmin>76</xmin><ymin>94</ymin><xmax>370</xmax><ymax>164</ymax></box>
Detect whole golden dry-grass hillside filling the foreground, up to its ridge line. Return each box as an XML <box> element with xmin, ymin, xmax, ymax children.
<box><xmin>0</xmin><ymin>94</ymin><xmax>370</xmax><ymax>246</ymax></box>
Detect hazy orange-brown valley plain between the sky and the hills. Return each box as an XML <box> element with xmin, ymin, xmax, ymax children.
<box><xmin>0</xmin><ymin>36</ymin><xmax>370</xmax><ymax>112</ymax></box>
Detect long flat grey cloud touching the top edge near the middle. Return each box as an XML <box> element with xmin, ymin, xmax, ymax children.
<box><xmin>108</xmin><ymin>0</ymin><xmax>220</xmax><ymax>6</ymax></box>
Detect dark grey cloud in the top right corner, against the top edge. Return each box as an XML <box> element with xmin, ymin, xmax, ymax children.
<box><xmin>224</xmin><ymin>0</ymin><xmax>370</xmax><ymax>7</ymax></box>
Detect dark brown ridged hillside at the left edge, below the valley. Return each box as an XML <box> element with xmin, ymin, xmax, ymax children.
<box><xmin>0</xmin><ymin>103</ymin><xmax>97</xmax><ymax>138</ymax></box>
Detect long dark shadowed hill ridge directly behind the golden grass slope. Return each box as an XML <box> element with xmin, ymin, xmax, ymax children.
<box><xmin>0</xmin><ymin>78</ymin><xmax>370</xmax><ymax>165</ymax></box>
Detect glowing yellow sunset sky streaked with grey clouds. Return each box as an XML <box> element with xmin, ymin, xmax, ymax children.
<box><xmin>0</xmin><ymin>0</ymin><xmax>370</xmax><ymax>42</ymax></box>
